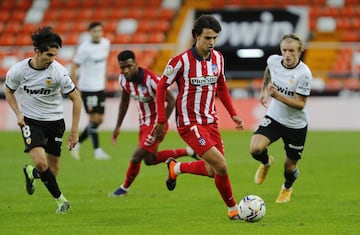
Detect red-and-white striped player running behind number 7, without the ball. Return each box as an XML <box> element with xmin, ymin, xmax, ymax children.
<box><xmin>109</xmin><ymin>50</ymin><xmax>196</xmax><ymax>197</ymax></box>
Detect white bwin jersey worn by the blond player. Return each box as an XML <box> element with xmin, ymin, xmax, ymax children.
<box><xmin>267</xmin><ymin>55</ymin><xmax>312</xmax><ymax>129</ymax></box>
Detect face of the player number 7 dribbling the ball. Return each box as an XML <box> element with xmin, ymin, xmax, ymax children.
<box><xmin>196</xmin><ymin>28</ymin><xmax>218</xmax><ymax>58</ymax></box>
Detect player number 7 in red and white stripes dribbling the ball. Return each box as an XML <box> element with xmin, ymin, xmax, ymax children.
<box><xmin>154</xmin><ymin>15</ymin><xmax>243</xmax><ymax>220</ymax></box>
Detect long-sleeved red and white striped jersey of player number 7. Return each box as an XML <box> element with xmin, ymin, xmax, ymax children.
<box><xmin>158</xmin><ymin>47</ymin><xmax>236</xmax><ymax>126</ymax></box>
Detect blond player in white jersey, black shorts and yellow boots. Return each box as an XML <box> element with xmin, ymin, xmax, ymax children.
<box><xmin>250</xmin><ymin>34</ymin><xmax>312</xmax><ymax>203</ymax></box>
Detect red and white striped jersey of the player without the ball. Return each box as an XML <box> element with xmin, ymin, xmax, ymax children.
<box><xmin>119</xmin><ymin>68</ymin><xmax>160</xmax><ymax>126</ymax></box>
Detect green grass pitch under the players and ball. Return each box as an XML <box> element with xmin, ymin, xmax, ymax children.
<box><xmin>0</xmin><ymin>131</ymin><xmax>360</xmax><ymax>235</ymax></box>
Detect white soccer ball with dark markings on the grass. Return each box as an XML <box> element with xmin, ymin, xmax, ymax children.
<box><xmin>239</xmin><ymin>195</ymin><xmax>266</xmax><ymax>222</ymax></box>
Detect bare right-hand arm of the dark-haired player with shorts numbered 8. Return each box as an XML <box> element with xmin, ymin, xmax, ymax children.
<box><xmin>67</xmin><ymin>89</ymin><xmax>82</xmax><ymax>150</ymax></box>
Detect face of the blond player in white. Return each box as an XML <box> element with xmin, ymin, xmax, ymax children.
<box><xmin>280</xmin><ymin>39</ymin><xmax>301</xmax><ymax>68</ymax></box>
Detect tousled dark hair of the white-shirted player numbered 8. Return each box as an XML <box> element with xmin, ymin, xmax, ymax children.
<box><xmin>31</xmin><ymin>26</ymin><xmax>62</xmax><ymax>52</ymax></box>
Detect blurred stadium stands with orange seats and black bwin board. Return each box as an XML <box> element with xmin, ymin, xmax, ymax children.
<box><xmin>0</xmin><ymin>0</ymin><xmax>360</xmax><ymax>130</ymax></box>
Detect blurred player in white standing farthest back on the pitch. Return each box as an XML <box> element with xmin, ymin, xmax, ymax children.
<box><xmin>70</xmin><ymin>22</ymin><xmax>110</xmax><ymax>160</ymax></box>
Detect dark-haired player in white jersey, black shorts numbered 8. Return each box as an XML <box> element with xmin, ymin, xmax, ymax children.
<box><xmin>5</xmin><ymin>27</ymin><xmax>82</xmax><ymax>213</ymax></box>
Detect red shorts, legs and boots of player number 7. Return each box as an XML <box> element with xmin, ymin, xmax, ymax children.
<box><xmin>166</xmin><ymin>124</ymin><xmax>240</xmax><ymax>219</ymax></box>
